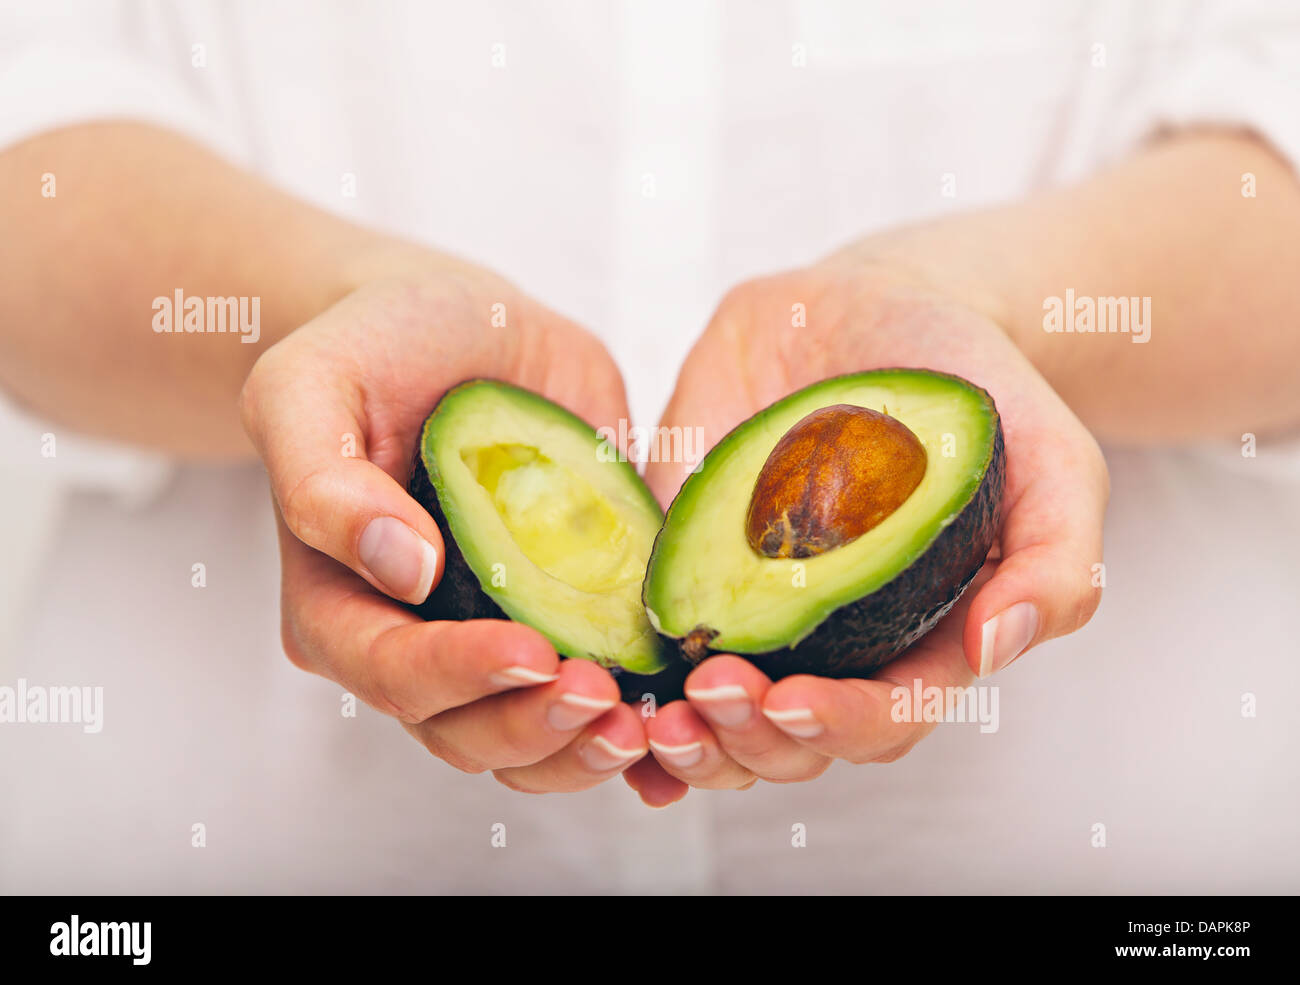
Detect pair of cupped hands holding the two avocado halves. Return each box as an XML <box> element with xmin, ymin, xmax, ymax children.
<box><xmin>241</xmin><ymin>251</ymin><xmax>1108</xmax><ymax>807</ymax></box>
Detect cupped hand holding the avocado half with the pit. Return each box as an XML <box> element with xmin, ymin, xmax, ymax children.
<box><xmin>628</xmin><ymin>257</ymin><xmax>1109</xmax><ymax>802</ymax></box>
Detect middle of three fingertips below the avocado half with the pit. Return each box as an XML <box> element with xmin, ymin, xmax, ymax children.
<box><xmin>686</xmin><ymin>655</ymin><xmax>829</xmax><ymax>782</ymax></box>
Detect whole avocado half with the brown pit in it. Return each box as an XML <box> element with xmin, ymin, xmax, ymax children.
<box><xmin>642</xmin><ymin>369</ymin><xmax>1005</xmax><ymax>677</ymax></box>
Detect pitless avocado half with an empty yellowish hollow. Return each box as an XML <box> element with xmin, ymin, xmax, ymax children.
<box><xmin>410</xmin><ymin>379</ymin><xmax>667</xmax><ymax>674</ymax></box>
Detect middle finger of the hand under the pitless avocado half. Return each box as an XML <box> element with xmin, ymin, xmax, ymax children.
<box><xmin>407</xmin><ymin>660</ymin><xmax>626</xmax><ymax>772</ymax></box>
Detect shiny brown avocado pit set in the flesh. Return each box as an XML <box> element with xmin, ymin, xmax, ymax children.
<box><xmin>745</xmin><ymin>404</ymin><xmax>926</xmax><ymax>557</ymax></box>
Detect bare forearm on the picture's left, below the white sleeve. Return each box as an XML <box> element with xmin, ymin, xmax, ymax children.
<box><xmin>0</xmin><ymin>123</ymin><xmax>436</xmax><ymax>460</ymax></box>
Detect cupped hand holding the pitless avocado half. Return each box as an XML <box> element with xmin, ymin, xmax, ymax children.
<box><xmin>241</xmin><ymin>255</ymin><xmax>670</xmax><ymax>793</ymax></box>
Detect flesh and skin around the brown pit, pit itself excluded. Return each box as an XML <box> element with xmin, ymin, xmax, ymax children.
<box><xmin>644</xmin><ymin>369</ymin><xmax>1004</xmax><ymax>676</ymax></box>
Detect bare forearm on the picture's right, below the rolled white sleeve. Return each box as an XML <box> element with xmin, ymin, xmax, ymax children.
<box><xmin>845</xmin><ymin>133</ymin><xmax>1300</xmax><ymax>442</ymax></box>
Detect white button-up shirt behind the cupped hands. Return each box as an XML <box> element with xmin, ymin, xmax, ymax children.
<box><xmin>0</xmin><ymin>0</ymin><xmax>1300</xmax><ymax>893</ymax></box>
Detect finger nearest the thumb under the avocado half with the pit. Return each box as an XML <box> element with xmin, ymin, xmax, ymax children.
<box><xmin>763</xmin><ymin>579</ymin><xmax>991</xmax><ymax>763</ymax></box>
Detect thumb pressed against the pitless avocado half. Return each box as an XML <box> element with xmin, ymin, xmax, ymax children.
<box><xmin>241</xmin><ymin>350</ymin><xmax>443</xmax><ymax>603</ymax></box>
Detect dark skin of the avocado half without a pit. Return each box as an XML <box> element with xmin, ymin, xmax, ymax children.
<box><xmin>407</xmin><ymin>448</ymin><xmax>692</xmax><ymax>706</ymax></box>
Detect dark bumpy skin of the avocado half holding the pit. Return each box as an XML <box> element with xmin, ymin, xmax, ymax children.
<box><xmin>675</xmin><ymin>420</ymin><xmax>1006</xmax><ymax>680</ymax></box>
